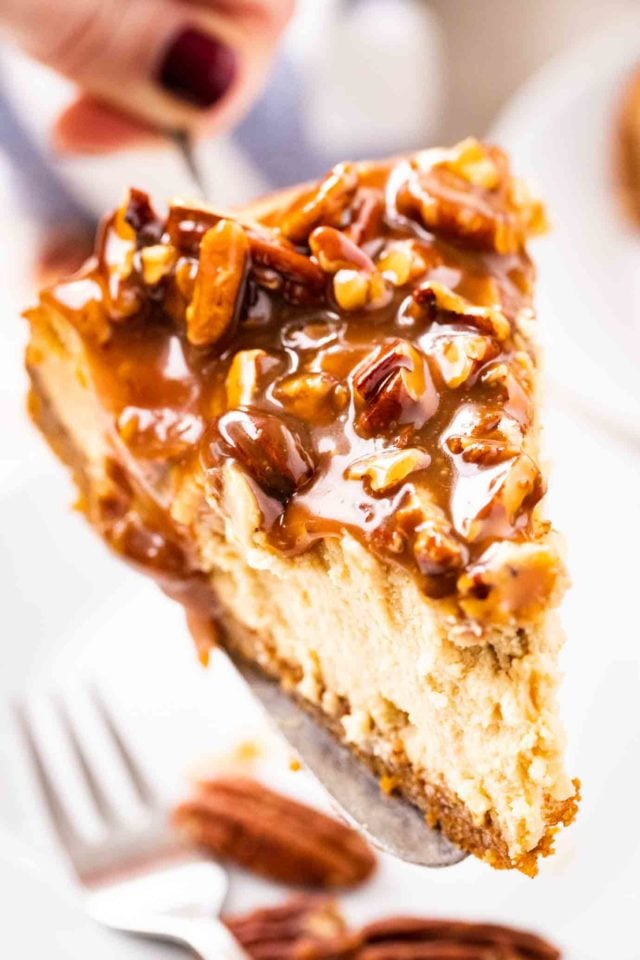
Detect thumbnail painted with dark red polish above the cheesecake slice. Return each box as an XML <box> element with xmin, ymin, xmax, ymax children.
<box><xmin>158</xmin><ymin>27</ymin><xmax>236</xmax><ymax>107</ymax></box>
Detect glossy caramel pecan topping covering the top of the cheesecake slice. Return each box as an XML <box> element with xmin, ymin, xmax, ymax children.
<box><xmin>35</xmin><ymin>141</ymin><xmax>556</xmax><ymax>603</ymax></box>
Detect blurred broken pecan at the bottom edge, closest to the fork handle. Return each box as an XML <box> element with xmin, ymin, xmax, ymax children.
<box><xmin>224</xmin><ymin>894</ymin><xmax>357</xmax><ymax>960</ymax></box>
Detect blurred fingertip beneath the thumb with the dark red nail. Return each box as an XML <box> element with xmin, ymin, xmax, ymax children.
<box><xmin>52</xmin><ymin>94</ymin><xmax>162</xmax><ymax>154</ymax></box>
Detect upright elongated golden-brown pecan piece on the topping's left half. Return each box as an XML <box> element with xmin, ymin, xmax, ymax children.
<box><xmin>187</xmin><ymin>220</ymin><xmax>249</xmax><ymax>347</ymax></box>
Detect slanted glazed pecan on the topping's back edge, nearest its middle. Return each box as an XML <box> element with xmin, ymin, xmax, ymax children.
<box><xmin>280</xmin><ymin>163</ymin><xmax>358</xmax><ymax>243</ymax></box>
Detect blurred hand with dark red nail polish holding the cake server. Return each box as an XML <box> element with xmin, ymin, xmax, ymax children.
<box><xmin>0</xmin><ymin>0</ymin><xmax>294</xmax><ymax>153</ymax></box>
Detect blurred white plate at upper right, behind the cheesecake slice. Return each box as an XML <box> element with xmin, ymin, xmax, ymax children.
<box><xmin>492</xmin><ymin>12</ymin><xmax>640</xmax><ymax>444</ymax></box>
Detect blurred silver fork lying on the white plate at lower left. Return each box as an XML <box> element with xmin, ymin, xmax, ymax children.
<box><xmin>15</xmin><ymin>689</ymin><xmax>248</xmax><ymax>960</ymax></box>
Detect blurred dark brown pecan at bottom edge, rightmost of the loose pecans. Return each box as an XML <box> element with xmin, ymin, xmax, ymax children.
<box><xmin>357</xmin><ymin>916</ymin><xmax>560</xmax><ymax>960</ymax></box>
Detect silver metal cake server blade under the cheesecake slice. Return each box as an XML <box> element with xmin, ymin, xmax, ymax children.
<box><xmin>228</xmin><ymin>654</ymin><xmax>468</xmax><ymax>867</ymax></box>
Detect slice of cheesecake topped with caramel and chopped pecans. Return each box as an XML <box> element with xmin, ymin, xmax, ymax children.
<box><xmin>27</xmin><ymin>140</ymin><xmax>577</xmax><ymax>874</ymax></box>
